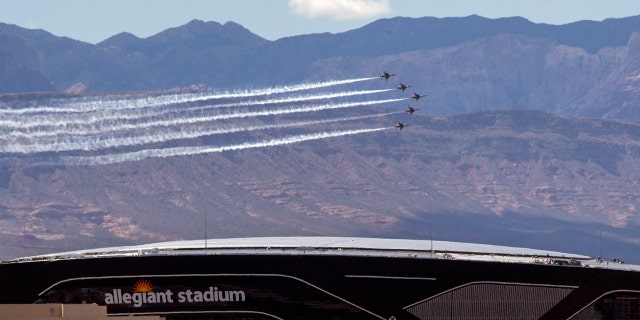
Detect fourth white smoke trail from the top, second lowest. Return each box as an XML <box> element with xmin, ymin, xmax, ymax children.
<box><xmin>0</xmin><ymin>112</ymin><xmax>399</xmax><ymax>154</ymax></box>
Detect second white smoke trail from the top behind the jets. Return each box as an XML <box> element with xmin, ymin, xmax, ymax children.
<box><xmin>0</xmin><ymin>89</ymin><xmax>394</xmax><ymax>129</ymax></box>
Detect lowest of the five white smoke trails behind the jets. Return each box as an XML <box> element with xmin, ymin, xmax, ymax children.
<box><xmin>61</xmin><ymin>128</ymin><xmax>389</xmax><ymax>166</ymax></box>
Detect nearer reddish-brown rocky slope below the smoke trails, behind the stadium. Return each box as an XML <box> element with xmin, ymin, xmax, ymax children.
<box><xmin>0</xmin><ymin>110</ymin><xmax>640</xmax><ymax>262</ymax></box>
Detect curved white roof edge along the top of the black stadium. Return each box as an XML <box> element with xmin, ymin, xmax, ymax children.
<box><xmin>13</xmin><ymin>237</ymin><xmax>591</xmax><ymax>261</ymax></box>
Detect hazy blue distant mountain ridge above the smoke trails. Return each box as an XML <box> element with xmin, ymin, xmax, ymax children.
<box><xmin>0</xmin><ymin>16</ymin><xmax>640</xmax><ymax>120</ymax></box>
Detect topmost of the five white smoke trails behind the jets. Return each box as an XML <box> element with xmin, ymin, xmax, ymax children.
<box><xmin>0</xmin><ymin>77</ymin><xmax>377</xmax><ymax>115</ymax></box>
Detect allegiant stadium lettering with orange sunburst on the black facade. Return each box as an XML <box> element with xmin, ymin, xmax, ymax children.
<box><xmin>104</xmin><ymin>280</ymin><xmax>246</xmax><ymax>308</ymax></box>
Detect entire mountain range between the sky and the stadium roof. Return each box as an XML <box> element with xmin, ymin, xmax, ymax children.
<box><xmin>0</xmin><ymin>16</ymin><xmax>640</xmax><ymax>262</ymax></box>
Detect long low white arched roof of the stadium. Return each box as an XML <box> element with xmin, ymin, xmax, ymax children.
<box><xmin>6</xmin><ymin>237</ymin><xmax>591</xmax><ymax>262</ymax></box>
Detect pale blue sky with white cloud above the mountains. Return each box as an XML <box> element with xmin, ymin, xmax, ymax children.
<box><xmin>0</xmin><ymin>0</ymin><xmax>640</xmax><ymax>44</ymax></box>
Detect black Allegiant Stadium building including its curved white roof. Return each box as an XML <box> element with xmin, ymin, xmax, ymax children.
<box><xmin>0</xmin><ymin>237</ymin><xmax>640</xmax><ymax>320</ymax></box>
